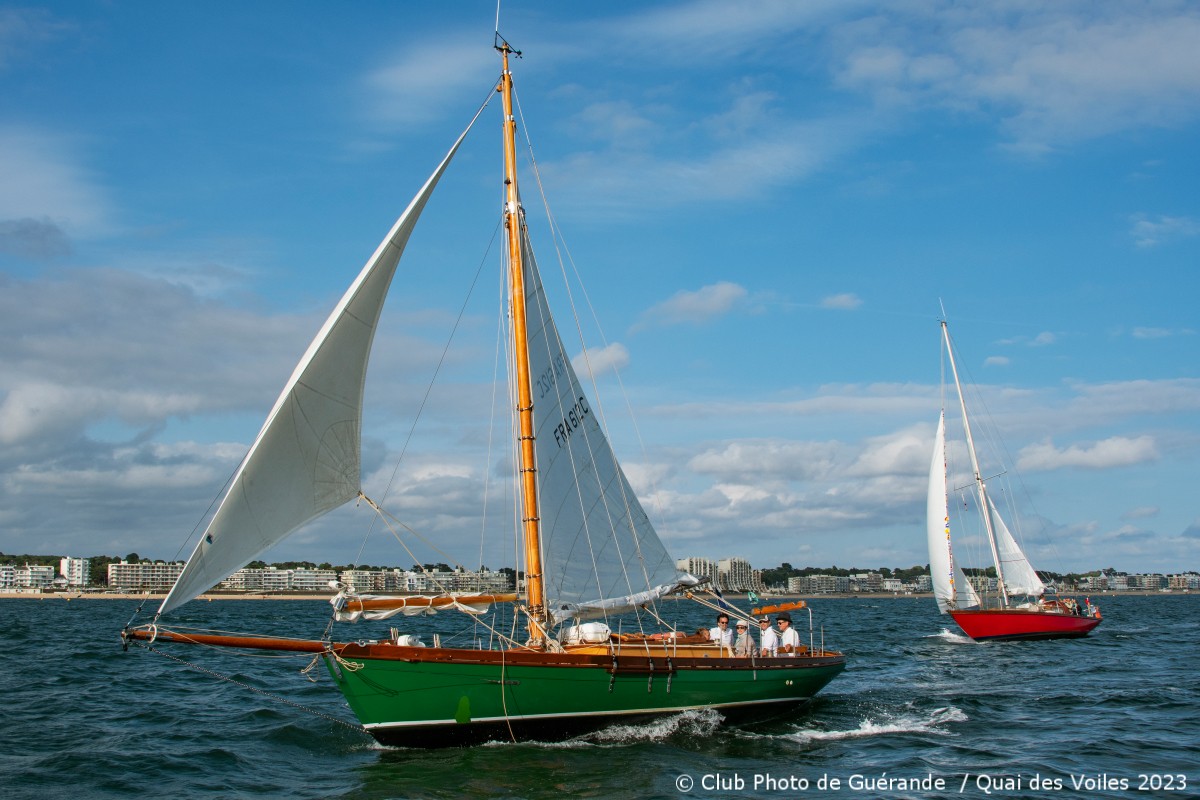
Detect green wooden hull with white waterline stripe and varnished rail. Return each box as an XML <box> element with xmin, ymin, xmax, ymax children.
<box><xmin>328</xmin><ymin>645</ymin><xmax>845</xmax><ymax>747</ymax></box>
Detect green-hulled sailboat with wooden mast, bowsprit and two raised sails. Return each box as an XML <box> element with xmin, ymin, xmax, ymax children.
<box><xmin>122</xmin><ymin>35</ymin><xmax>845</xmax><ymax>746</ymax></box>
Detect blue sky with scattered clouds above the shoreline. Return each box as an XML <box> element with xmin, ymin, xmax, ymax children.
<box><xmin>0</xmin><ymin>0</ymin><xmax>1200</xmax><ymax>572</ymax></box>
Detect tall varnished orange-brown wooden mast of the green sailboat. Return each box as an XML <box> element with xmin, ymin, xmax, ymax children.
<box><xmin>496</xmin><ymin>38</ymin><xmax>547</xmax><ymax>644</ymax></box>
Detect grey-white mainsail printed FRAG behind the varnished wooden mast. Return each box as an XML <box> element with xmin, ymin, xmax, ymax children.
<box><xmin>524</xmin><ymin>235</ymin><xmax>698</xmax><ymax>621</ymax></box>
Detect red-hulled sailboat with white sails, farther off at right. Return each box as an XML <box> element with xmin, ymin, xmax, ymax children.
<box><xmin>926</xmin><ymin>320</ymin><xmax>1100</xmax><ymax>640</ymax></box>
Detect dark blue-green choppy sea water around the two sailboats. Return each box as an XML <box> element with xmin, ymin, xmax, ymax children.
<box><xmin>0</xmin><ymin>595</ymin><xmax>1200</xmax><ymax>800</ymax></box>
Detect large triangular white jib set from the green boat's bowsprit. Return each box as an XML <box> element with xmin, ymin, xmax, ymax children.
<box><xmin>158</xmin><ymin>122</ymin><xmax>479</xmax><ymax>614</ymax></box>
